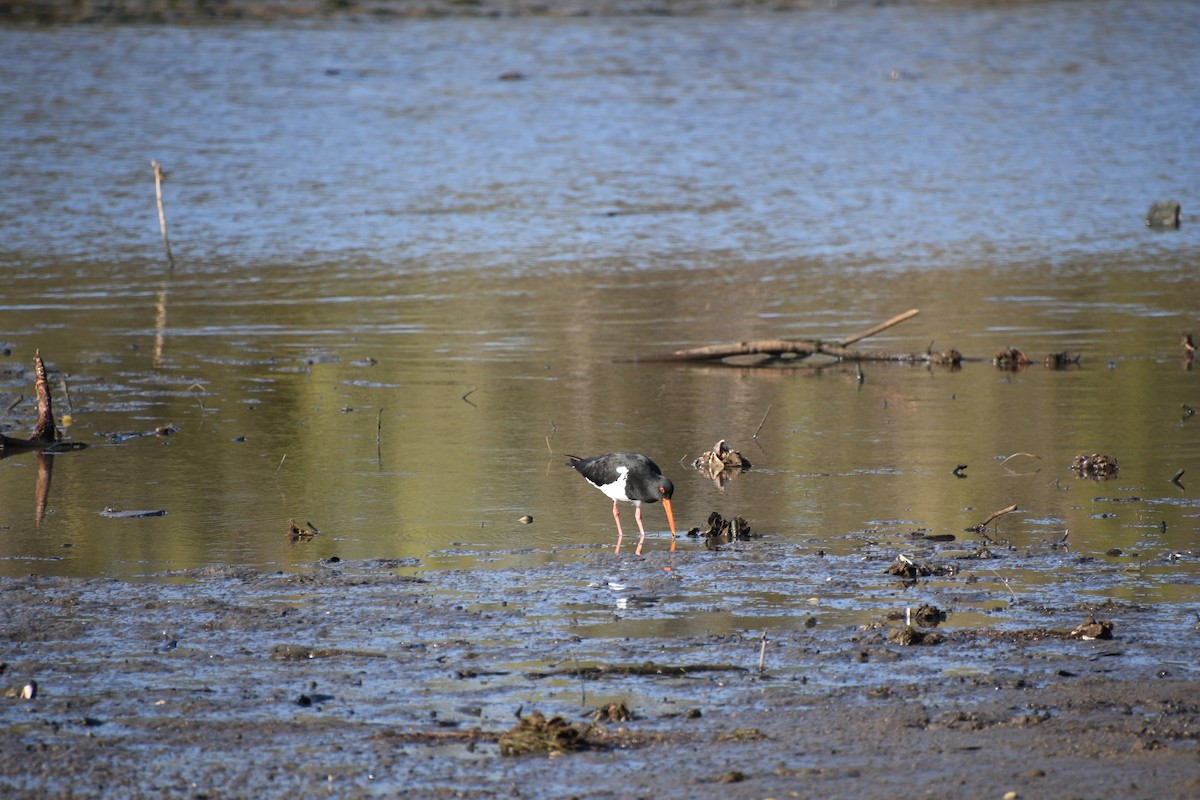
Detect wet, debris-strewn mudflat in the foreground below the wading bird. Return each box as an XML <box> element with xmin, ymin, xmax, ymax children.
<box><xmin>0</xmin><ymin>551</ymin><xmax>1200</xmax><ymax>798</ymax></box>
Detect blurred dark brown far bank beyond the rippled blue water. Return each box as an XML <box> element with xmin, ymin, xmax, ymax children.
<box><xmin>0</xmin><ymin>0</ymin><xmax>1051</xmax><ymax>24</ymax></box>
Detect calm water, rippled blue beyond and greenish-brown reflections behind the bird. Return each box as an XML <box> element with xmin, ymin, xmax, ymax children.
<box><xmin>0</xmin><ymin>2</ymin><xmax>1200</xmax><ymax>613</ymax></box>
